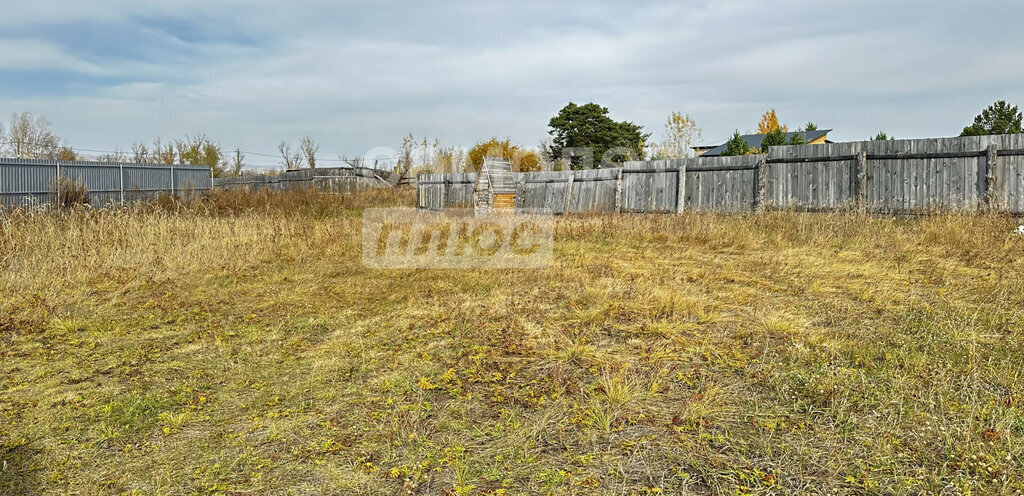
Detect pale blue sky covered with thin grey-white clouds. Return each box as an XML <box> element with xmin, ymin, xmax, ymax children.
<box><xmin>0</xmin><ymin>0</ymin><xmax>1024</xmax><ymax>165</ymax></box>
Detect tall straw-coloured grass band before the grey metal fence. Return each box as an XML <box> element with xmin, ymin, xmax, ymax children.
<box><xmin>0</xmin><ymin>190</ymin><xmax>410</xmax><ymax>307</ymax></box>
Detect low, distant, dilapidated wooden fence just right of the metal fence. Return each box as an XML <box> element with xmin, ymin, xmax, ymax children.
<box><xmin>213</xmin><ymin>167</ymin><xmax>399</xmax><ymax>193</ymax></box>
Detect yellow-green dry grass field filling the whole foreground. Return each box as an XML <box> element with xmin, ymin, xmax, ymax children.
<box><xmin>0</xmin><ymin>188</ymin><xmax>1024</xmax><ymax>495</ymax></box>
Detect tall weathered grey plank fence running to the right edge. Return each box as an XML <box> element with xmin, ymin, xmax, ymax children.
<box><xmin>417</xmin><ymin>134</ymin><xmax>1024</xmax><ymax>213</ymax></box>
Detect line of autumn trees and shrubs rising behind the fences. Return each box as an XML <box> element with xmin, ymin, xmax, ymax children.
<box><xmin>0</xmin><ymin>100</ymin><xmax>1024</xmax><ymax>176</ymax></box>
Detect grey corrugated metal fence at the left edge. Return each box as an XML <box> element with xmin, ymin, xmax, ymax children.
<box><xmin>0</xmin><ymin>158</ymin><xmax>212</xmax><ymax>206</ymax></box>
